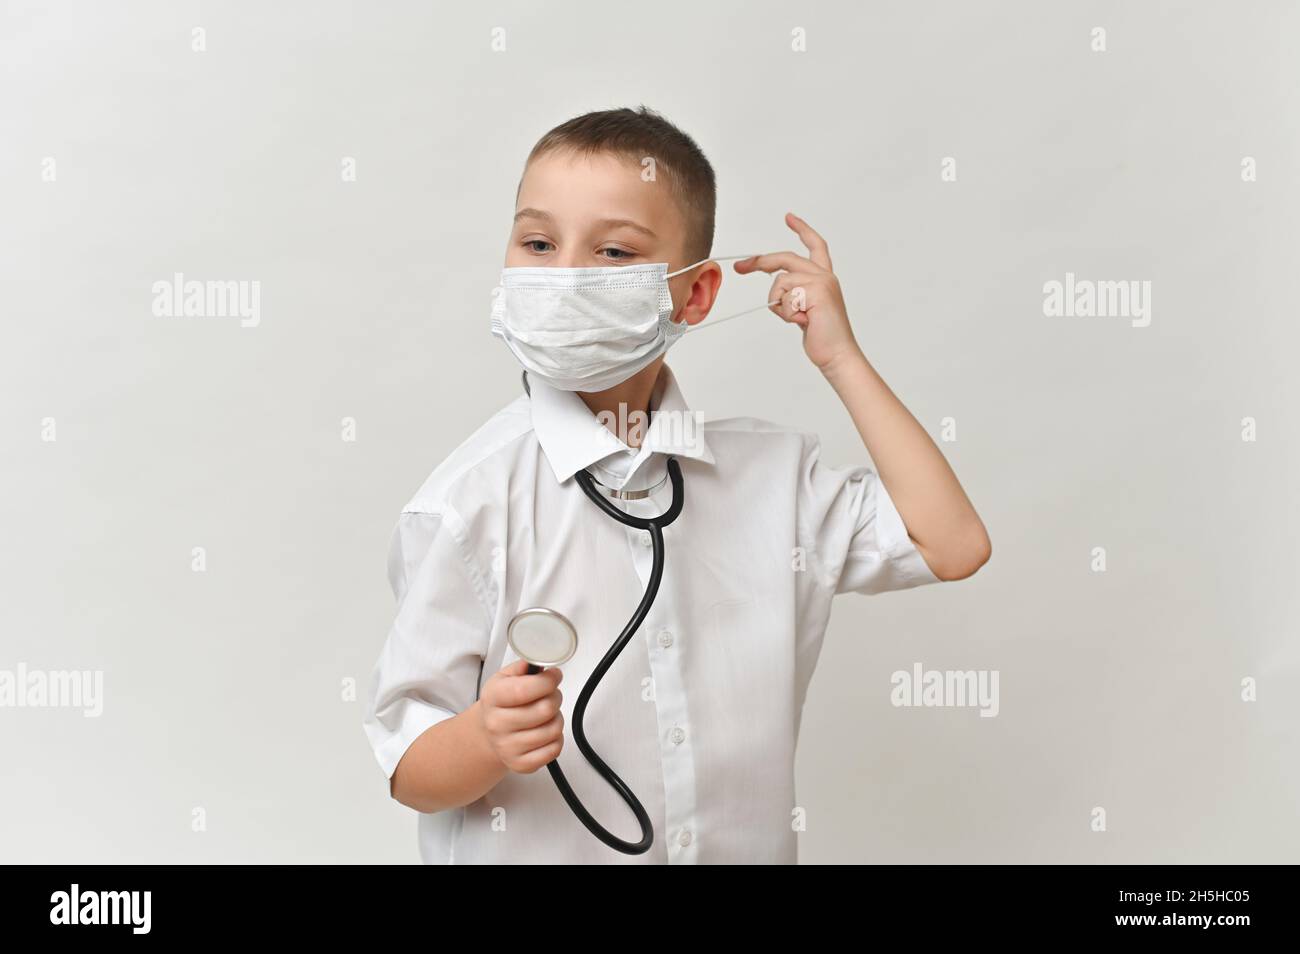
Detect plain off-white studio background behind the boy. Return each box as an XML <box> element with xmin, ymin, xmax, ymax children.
<box><xmin>0</xmin><ymin>1</ymin><xmax>1300</xmax><ymax>863</ymax></box>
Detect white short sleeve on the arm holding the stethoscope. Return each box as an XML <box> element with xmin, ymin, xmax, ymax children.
<box><xmin>363</xmin><ymin>512</ymin><xmax>490</xmax><ymax>779</ymax></box>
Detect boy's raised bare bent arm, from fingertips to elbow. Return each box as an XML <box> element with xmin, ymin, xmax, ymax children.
<box><xmin>736</xmin><ymin>214</ymin><xmax>992</xmax><ymax>580</ymax></box>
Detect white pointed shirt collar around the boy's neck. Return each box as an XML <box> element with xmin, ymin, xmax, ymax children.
<box><xmin>524</xmin><ymin>363</ymin><xmax>714</xmax><ymax>486</ymax></box>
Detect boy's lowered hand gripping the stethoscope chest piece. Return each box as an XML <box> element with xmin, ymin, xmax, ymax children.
<box><xmin>478</xmin><ymin>659</ymin><xmax>564</xmax><ymax>775</ymax></box>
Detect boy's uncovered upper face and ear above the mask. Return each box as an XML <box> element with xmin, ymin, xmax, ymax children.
<box><xmin>506</xmin><ymin>149</ymin><xmax>722</xmax><ymax>324</ymax></box>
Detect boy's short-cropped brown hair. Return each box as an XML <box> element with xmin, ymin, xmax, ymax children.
<box><xmin>524</xmin><ymin>105</ymin><xmax>718</xmax><ymax>261</ymax></box>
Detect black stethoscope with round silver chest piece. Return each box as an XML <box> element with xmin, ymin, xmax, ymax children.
<box><xmin>506</xmin><ymin>376</ymin><xmax>684</xmax><ymax>855</ymax></box>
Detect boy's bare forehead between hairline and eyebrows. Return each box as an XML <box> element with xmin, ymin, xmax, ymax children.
<box><xmin>515</xmin><ymin>149</ymin><xmax>683</xmax><ymax>238</ymax></box>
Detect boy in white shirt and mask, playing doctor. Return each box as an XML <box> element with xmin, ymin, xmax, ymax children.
<box><xmin>365</xmin><ymin>107</ymin><xmax>989</xmax><ymax>863</ymax></box>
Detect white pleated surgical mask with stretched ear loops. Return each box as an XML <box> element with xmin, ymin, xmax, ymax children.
<box><xmin>491</xmin><ymin>255</ymin><xmax>775</xmax><ymax>391</ymax></box>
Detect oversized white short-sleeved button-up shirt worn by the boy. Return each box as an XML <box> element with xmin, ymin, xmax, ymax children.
<box><xmin>364</xmin><ymin>364</ymin><xmax>937</xmax><ymax>864</ymax></box>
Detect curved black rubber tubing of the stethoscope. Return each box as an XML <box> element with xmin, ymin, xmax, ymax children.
<box><xmin>528</xmin><ymin>458</ymin><xmax>684</xmax><ymax>855</ymax></box>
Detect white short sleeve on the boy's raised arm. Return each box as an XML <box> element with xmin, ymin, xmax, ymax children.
<box><xmin>800</xmin><ymin>434</ymin><xmax>939</xmax><ymax>594</ymax></box>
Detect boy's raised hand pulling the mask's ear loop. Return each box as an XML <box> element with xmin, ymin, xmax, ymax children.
<box><xmin>736</xmin><ymin>212</ymin><xmax>861</xmax><ymax>373</ymax></box>
